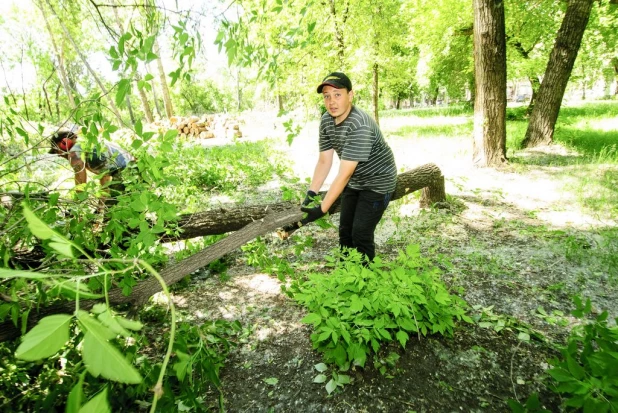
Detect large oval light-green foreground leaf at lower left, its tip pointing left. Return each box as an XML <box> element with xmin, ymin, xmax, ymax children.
<box><xmin>15</xmin><ymin>314</ymin><xmax>73</xmax><ymax>361</ymax></box>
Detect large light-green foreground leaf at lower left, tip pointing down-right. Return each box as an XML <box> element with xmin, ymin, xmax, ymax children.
<box><xmin>77</xmin><ymin>311</ymin><xmax>142</xmax><ymax>384</ymax></box>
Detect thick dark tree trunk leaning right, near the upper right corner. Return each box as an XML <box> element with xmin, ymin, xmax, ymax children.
<box><xmin>521</xmin><ymin>0</ymin><xmax>594</xmax><ymax>148</ymax></box>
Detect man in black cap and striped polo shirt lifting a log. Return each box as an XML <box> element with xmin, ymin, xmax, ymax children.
<box><xmin>301</xmin><ymin>72</ymin><xmax>397</xmax><ymax>261</ymax></box>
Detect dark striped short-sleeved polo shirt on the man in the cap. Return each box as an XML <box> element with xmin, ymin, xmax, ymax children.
<box><xmin>320</xmin><ymin>106</ymin><xmax>397</xmax><ymax>194</ymax></box>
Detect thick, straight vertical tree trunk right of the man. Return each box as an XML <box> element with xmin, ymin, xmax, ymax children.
<box><xmin>473</xmin><ymin>0</ymin><xmax>506</xmax><ymax>166</ymax></box>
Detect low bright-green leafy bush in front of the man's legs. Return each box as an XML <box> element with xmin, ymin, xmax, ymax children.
<box><xmin>288</xmin><ymin>245</ymin><xmax>472</xmax><ymax>369</ymax></box>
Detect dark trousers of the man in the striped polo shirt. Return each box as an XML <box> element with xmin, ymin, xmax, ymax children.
<box><xmin>339</xmin><ymin>187</ymin><xmax>392</xmax><ymax>261</ymax></box>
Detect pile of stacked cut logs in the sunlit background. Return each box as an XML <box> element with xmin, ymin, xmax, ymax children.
<box><xmin>162</xmin><ymin>115</ymin><xmax>243</xmax><ymax>139</ymax></box>
